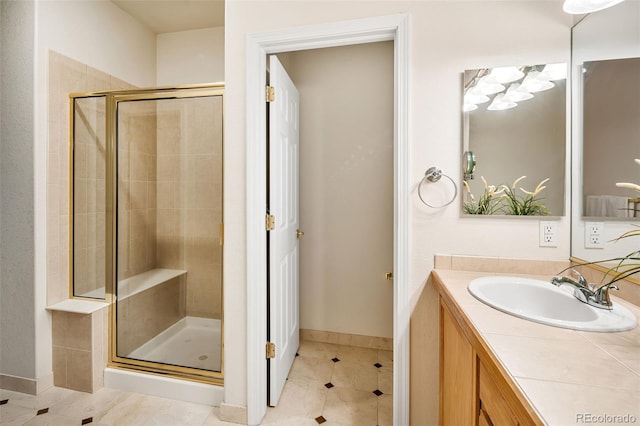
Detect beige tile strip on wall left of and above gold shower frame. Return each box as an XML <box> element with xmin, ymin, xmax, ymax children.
<box><xmin>47</xmin><ymin>51</ymin><xmax>133</xmax><ymax>305</ymax></box>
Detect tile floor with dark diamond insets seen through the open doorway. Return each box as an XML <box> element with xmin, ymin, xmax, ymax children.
<box><xmin>262</xmin><ymin>341</ymin><xmax>393</xmax><ymax>426</ymax></box>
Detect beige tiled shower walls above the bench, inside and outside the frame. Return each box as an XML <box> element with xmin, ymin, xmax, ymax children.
<box><xmin>47</xmin><ymin>52</ymin><xmax>222</xmax><ymax>319</ymax></box>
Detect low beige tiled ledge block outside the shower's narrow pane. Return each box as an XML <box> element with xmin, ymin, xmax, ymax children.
<box><xmin>47</xmin><ymin>299</ymin><xmax>109</xmax><ymax>392</ymax></box>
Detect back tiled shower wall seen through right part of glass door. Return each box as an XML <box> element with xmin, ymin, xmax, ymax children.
<box><xmin>157</xmin><ymin>96</ymin><xmax>222</xmax><ymax>319</ymax></box>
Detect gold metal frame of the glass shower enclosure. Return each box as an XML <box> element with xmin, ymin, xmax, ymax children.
<box><xmin>69</xmin><ymin>83</ymin><xmax>224</xmax><ymax>385</ymax></box>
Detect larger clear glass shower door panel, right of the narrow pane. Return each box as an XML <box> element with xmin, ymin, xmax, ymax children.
<box><xmin>113</xmin><ymin>89</ymin><xmax>223</xmax><ymax>377</ymax></box>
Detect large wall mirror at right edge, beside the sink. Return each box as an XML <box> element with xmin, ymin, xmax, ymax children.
<box><xmin>571</xmin><ymin>2</ymin><xmax>640</xmax><ymax>261</ymax></box>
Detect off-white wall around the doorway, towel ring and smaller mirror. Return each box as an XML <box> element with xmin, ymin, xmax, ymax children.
<box><xmin>224</xmin><ymin>0</ymin><xmax>572</xmax><ymax>412</ymax></box>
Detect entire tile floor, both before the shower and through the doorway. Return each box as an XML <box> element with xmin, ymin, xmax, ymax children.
<box><xmin>0</xmin><ymin>342</ymin><xmax>393</xmax><ymax>426</ymax></box>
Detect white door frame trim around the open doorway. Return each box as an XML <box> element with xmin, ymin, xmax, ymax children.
<box><xmin>246</xmin><ymin>14</ymin><xmax>411</xmax><ymax>425</ymax></box>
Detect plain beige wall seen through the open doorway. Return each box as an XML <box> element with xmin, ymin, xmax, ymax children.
<box><xmin>286</xmin><ymin>42</ymin><xmax>393</xmax><ymax>337</ymax></box>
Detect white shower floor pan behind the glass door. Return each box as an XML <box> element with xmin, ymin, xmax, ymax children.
<box><xmin>126</xmin><ymin>317</ymin><xmax>221</xmax><ymax>371</ymax></box>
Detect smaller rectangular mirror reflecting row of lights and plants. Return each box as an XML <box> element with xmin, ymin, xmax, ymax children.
<box><xmin>462</xmin><ymin>64</ymin><xmax>567</xmax><ymax>216</ymax></box>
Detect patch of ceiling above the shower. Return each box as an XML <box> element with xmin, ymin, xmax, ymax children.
<box><xmin>112</xmin><ymin>0</ymin><xmax>224</xmax><ymax>34</ymax></box>
